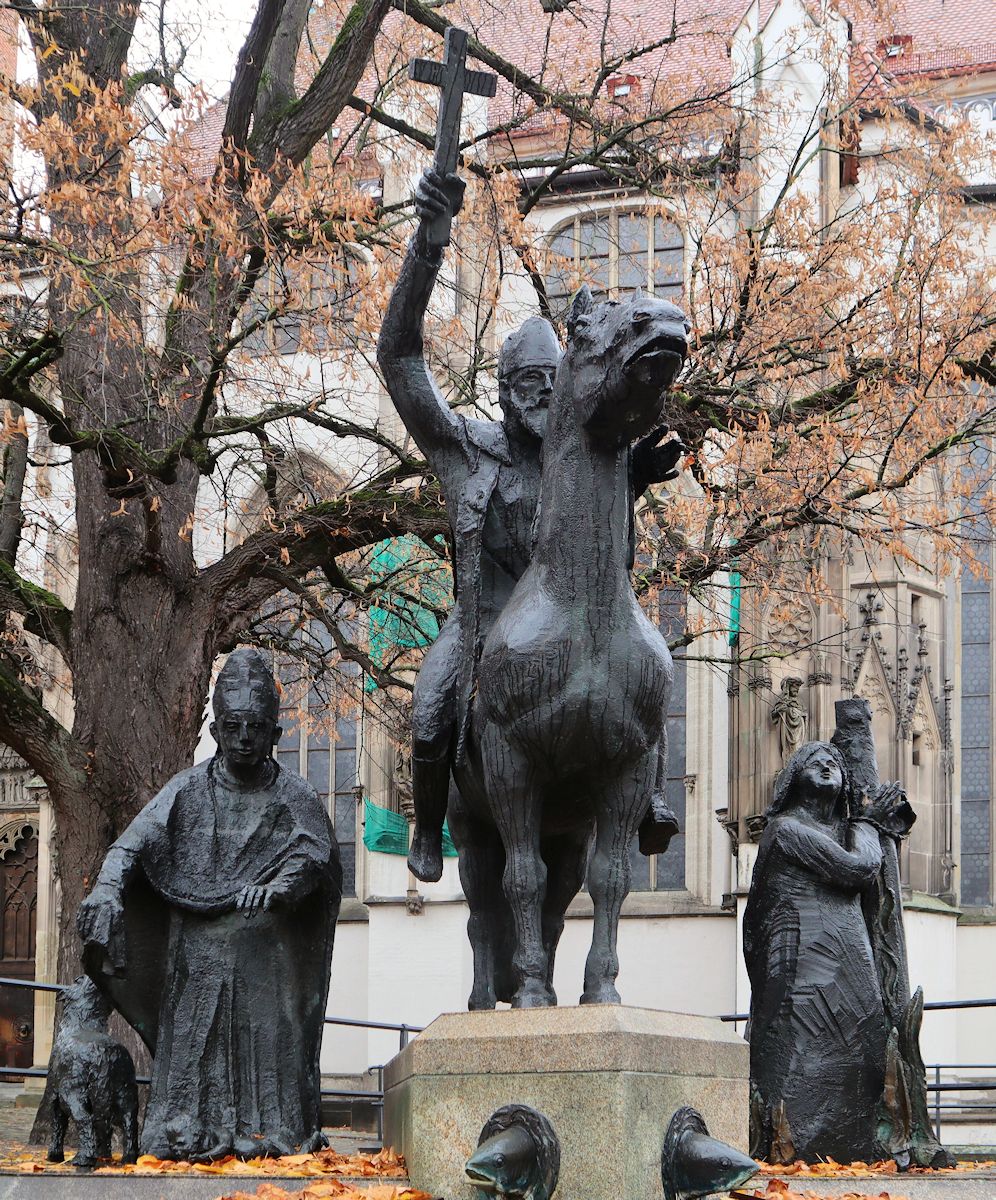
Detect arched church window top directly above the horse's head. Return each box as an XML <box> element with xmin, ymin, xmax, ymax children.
<box><xmin>546</xmin><ymin>211</ymin><xmax>685</xmax><ymax>316</ymax></box>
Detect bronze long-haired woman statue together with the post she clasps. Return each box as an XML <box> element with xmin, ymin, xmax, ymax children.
<box><xmin>744</xmin><ymin>701</ymin><xmax>948</xmax><ymax>1168</ymax></box>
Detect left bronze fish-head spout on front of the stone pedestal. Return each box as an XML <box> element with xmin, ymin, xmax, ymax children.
<box><xmin>464</xmin><ymin>1104</ymin><xmax>560</xmax><ymax>1200</ymax></box>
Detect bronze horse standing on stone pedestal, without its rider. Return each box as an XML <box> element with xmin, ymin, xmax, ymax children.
<box><xmin>449</xmin><ymin>287</ymin><xmax>689</xmax><ymax>1009</ymax></box>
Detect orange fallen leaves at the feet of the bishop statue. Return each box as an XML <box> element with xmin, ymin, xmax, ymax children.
<box><xmin>0</xmin><ymin>1150</ymin><xmax>410</xmax><ymax>1180</ymax></box>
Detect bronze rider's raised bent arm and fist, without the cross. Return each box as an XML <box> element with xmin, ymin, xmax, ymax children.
<box><xmin>377</xmin><ymin>175</ymin><xmax>463</xmax><ymax>470</ymax></box>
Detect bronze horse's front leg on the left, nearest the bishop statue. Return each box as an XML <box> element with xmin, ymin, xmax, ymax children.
<box><xmin>481</xmin><ymin>726</ymin><xmax>557</xmax><ymax>1008</ymax></box>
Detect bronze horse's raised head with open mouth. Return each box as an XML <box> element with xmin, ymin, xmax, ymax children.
<box><xmin>564</xmin><ymin>286</ymin><xmax>691</xmax><ymax>446</ymax></box>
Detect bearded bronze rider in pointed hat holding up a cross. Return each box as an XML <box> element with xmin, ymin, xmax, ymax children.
<box><xmin>377</xmin><ymin>35</ymin><xmax>683</xmax><ymax>902</ymax></box>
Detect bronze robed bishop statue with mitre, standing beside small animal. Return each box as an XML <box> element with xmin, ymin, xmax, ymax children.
<box><xmin>78</xmin><ymin>649</ymin><xmax>342</xmax><ymax>1162</ymax></box>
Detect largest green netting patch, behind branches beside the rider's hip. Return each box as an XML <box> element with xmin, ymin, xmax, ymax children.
<box><xmin>365</xmin><ymin>534</ymin><xmax>452</xmax><ymax>691</ymax></box>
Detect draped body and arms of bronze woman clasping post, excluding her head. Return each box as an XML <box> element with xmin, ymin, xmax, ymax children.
<box><xmin>744</xmin><ymin>772</ymin><xmax>888</xmax><ymax>1162</ymax></box>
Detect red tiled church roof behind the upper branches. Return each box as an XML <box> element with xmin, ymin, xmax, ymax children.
<box><xmin>187</xmin><ymin>0</ymin><xmax>996</xmax><ymax>171</ymax></box>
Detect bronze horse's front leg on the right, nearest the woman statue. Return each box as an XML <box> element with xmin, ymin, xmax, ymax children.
<box><xmin>581</xmin><ymin>748</ymin><xmax>658</xmax><ymax>1004</ymax></box>
